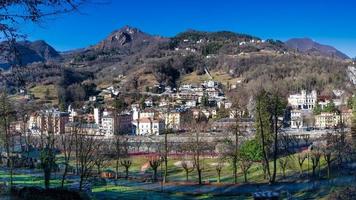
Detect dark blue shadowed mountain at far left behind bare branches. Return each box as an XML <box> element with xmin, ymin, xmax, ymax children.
<box><xmin>0</xmin><ymin>40</ymin><xmax>61</xmax><ymax>68</ymax></box>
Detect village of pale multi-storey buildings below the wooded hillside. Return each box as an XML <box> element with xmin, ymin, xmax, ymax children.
<box><xmin>14</xmin><ymin>75</ymin><xmax>352</xmax><ymax>141</ymax></box>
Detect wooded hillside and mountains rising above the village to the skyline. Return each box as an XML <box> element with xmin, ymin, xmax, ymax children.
<box><xmin>0</xmin><ymin>26</ymin><xmax>351</xmax><ymax>95</ymax></box>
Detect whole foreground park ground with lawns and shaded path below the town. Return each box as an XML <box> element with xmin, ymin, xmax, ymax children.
<box><xmin>0</xmin><ymin>154</ymin><xmax>356</xmax><ymax>199</ymax></box>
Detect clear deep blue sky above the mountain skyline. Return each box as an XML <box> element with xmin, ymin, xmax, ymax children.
<box><xmin>19</xmin><ymin>0</ymin><xmax>356</xmax><ymax>57</ymax></box>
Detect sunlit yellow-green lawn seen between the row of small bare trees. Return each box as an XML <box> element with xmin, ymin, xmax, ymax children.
<box><xmin>98</xmin><ymin>152</ymin><xmax>326</xmax><ymax>183</ymax></box>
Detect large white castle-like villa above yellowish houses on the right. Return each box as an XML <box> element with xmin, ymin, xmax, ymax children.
<box><xmin>288</xmin><ymin>90</ymin><xmax>317</xmax><ymax>110</ymax></box>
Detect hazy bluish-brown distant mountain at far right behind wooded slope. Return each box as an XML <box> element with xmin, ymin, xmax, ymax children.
<box><xmin>285</xmin><ymin>38</ymin><xmax>349</xmax><ymax>59</ymax></box>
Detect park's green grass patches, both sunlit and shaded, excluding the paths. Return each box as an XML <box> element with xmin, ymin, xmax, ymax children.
<box><xmin>0</xmin><ymin>152</ymin><xmax>341</xmax><ymax>199</ymax></box>
